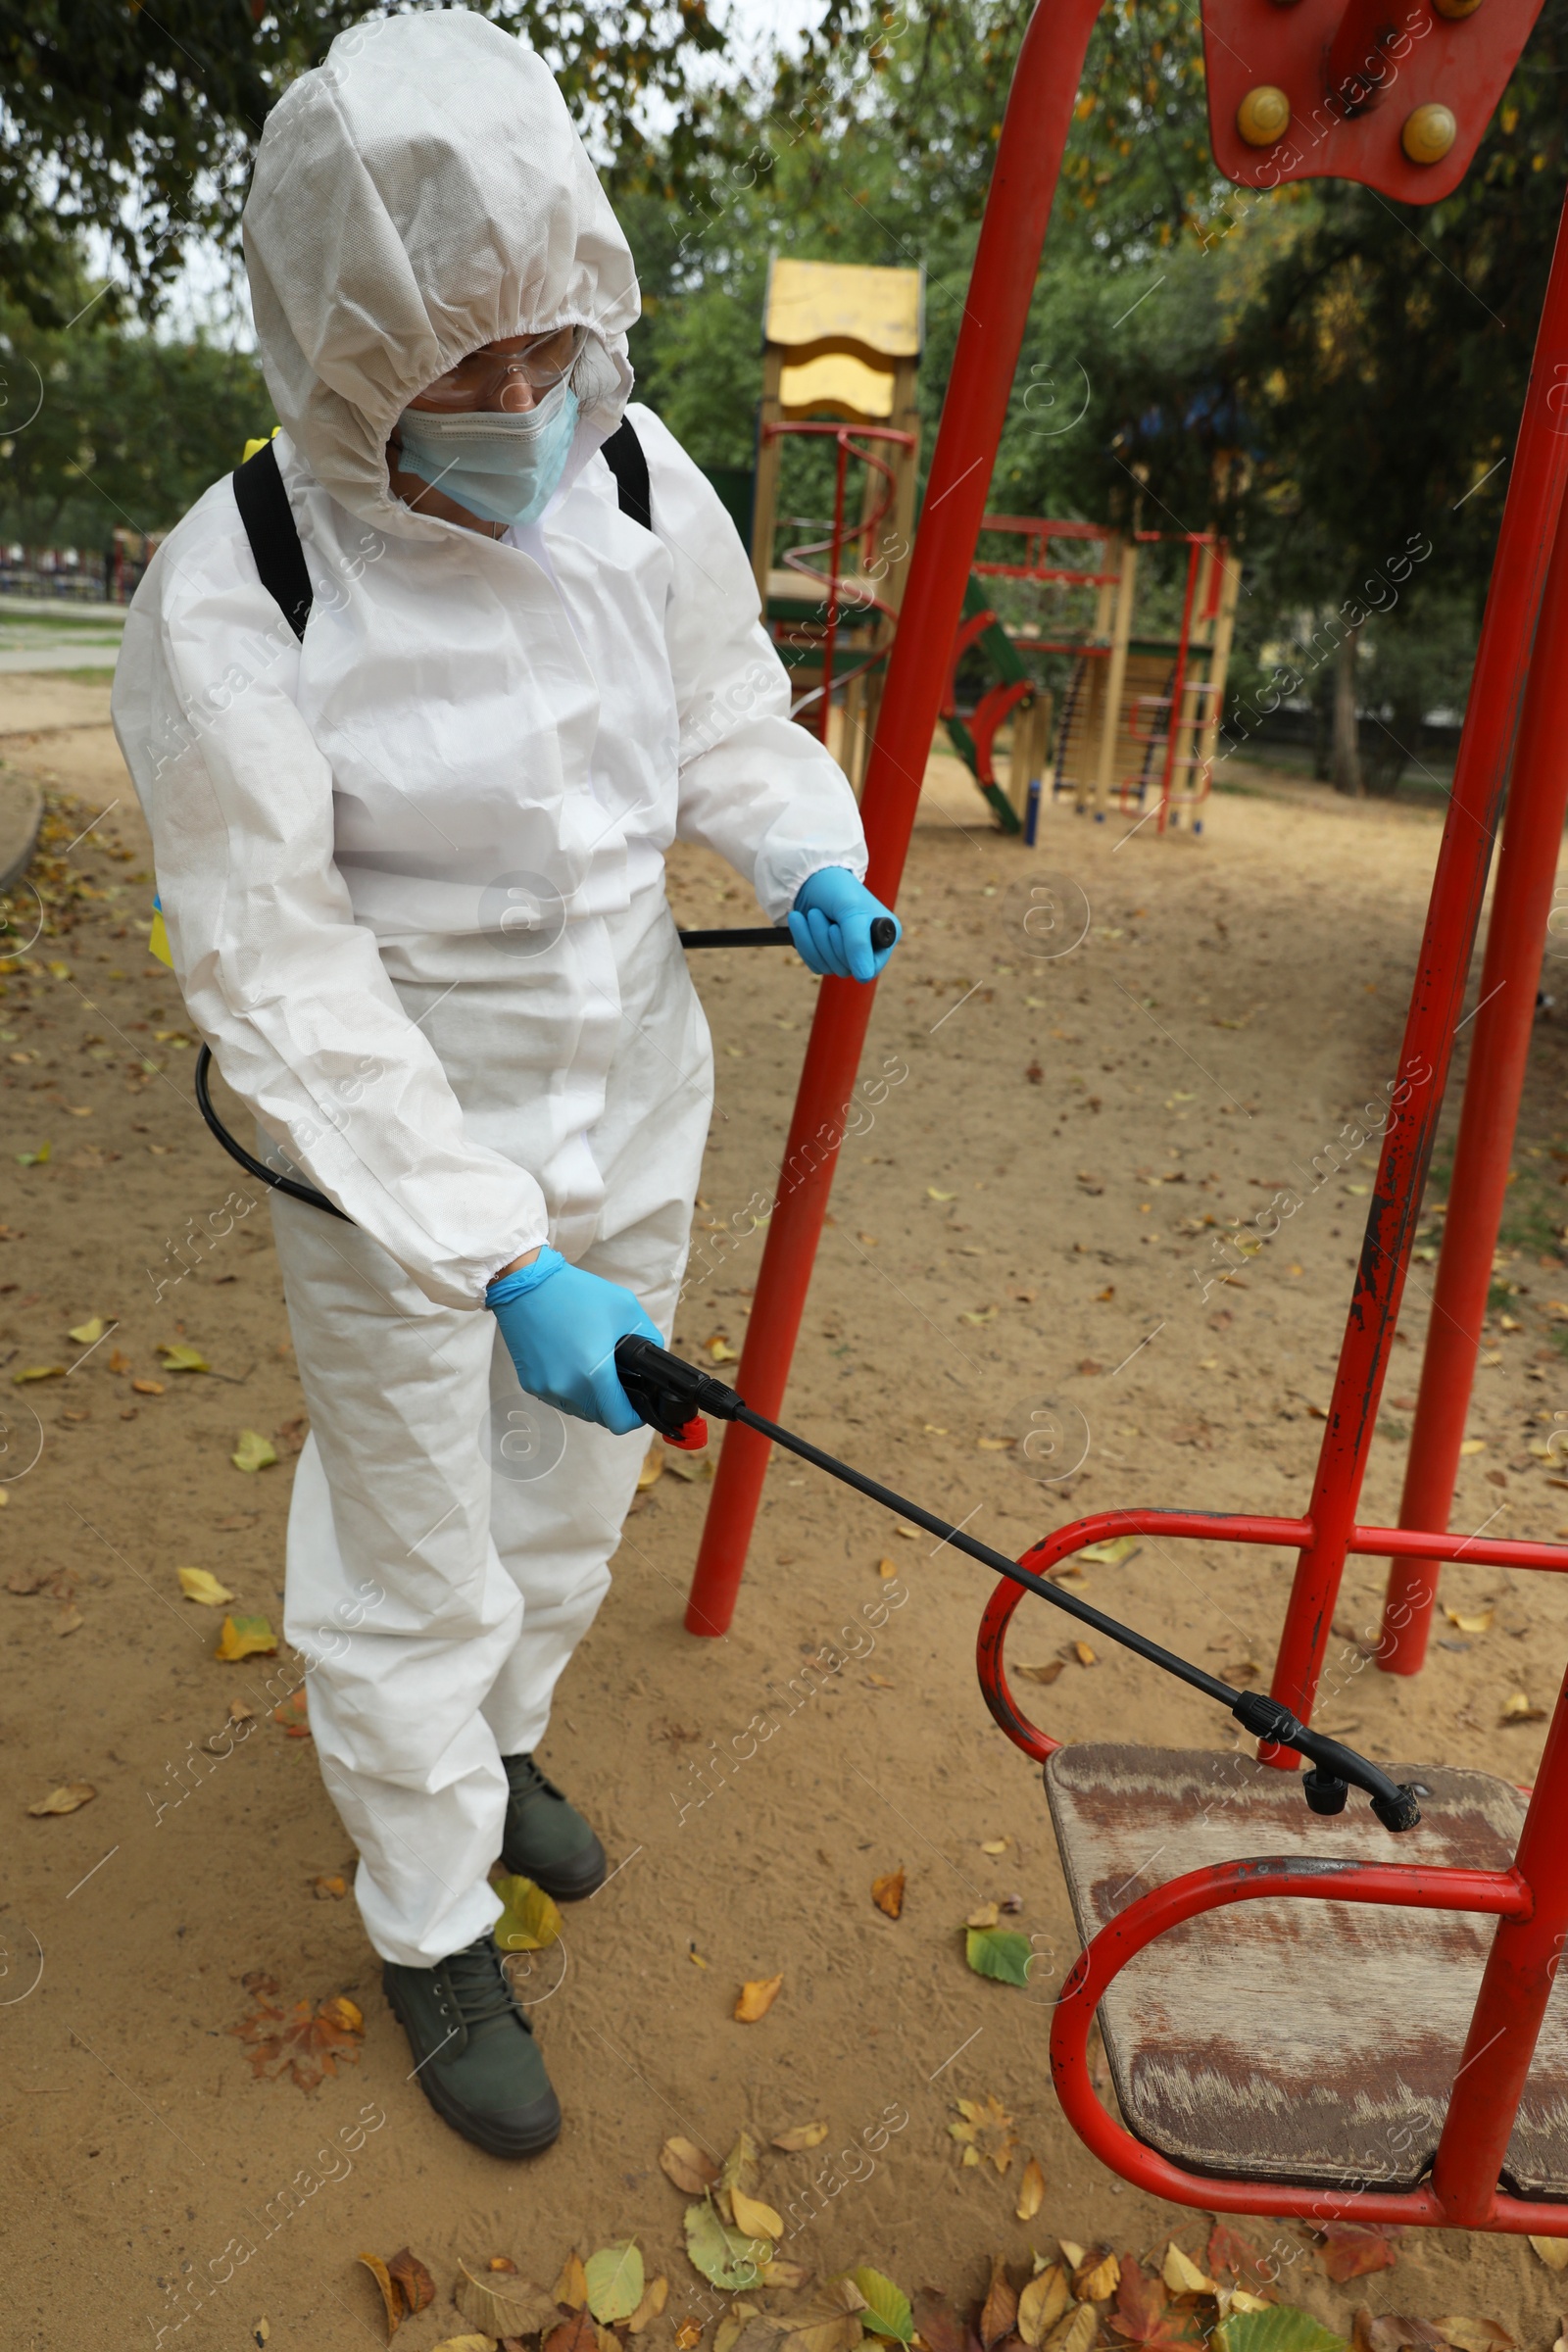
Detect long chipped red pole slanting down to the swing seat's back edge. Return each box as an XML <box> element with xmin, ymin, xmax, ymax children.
<box><xmin>1267</xmin><ymin>192</ymin><xmax>1568</xmax><ymax>1769</ymax></box>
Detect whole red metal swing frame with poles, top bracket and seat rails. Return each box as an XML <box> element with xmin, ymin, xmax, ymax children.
<box><xmin>686</xmin><ymin>0</ymin><xmax>1568</xmax><ymax>2236</ymax></box>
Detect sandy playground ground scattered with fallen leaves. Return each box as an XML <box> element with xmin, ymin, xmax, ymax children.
<box><xmin>0</xmin><ymin>677</ymin><xmax>1568</xmax><ymax>2352</ymax></box>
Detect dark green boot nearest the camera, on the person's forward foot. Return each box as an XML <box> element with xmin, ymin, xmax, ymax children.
<box><xmin>381</xmin><ymin>1936</ymin><xmax>562</xmax><ymax>2157</ymax></box>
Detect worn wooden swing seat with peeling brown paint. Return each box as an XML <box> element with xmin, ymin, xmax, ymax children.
<box><xmin>1044</xmin><ymin>1745</ymin><xmax>1568</xmax><ymax>2199</ymax></box>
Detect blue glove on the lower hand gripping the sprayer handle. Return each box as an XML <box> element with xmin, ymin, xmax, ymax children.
<box><xmin>484</xmin><ymin>1249</ymin><xmax>665</xmax><ymax>1437</ymax></box>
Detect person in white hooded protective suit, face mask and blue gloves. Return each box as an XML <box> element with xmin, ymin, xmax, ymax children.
<box><xmin>116</xmin><ymin>12</ymin><xmax>886</xmax><ymax>2154</ymax></box>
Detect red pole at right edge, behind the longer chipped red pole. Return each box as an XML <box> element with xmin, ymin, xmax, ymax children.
<box><xmin>1378</xmin><ymin>482</ymin><xmax>1568</xmax><ymax>1675</ymax></box>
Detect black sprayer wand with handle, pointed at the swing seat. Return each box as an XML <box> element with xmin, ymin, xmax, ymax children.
<box><xmin>615</xmin><ymin>1339</ymin><xmax>1420</xmax><ymax>1830</ymax></box>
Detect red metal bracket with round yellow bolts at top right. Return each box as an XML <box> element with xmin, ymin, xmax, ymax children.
<box><xmin>1203</xmin><ymin>0</ymin><xmax>1543</xmax><ymax>205</ymax></box>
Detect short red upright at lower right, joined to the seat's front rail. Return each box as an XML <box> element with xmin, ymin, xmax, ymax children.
<box><xmin>1432</xmin><ymin>1665</ymin><xmax>1568</xmax><ymax>2230</ymax></box>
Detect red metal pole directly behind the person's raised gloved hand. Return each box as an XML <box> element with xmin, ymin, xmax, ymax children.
<box><xmin>686</xmin><ymin>0</ymin><xmax>1101</xmax><ymax>1635</ymax></box>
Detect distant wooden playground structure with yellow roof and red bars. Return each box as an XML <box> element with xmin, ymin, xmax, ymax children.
<box><xmin>750</xmin><ymin>259</ymin><xmax>1239</xmax><ymax>847</ymax></box>
